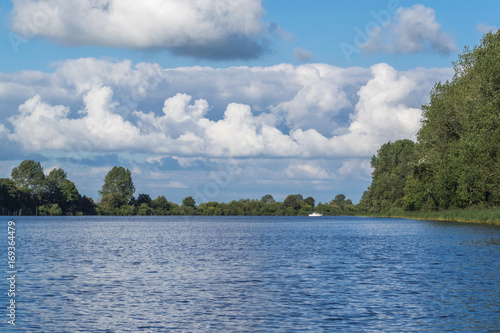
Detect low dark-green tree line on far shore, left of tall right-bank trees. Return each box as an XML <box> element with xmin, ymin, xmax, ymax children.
<box><xmin>0</xmin><ymin>160</ymin><xmax>356</xmax><ymax>216</ymax></box>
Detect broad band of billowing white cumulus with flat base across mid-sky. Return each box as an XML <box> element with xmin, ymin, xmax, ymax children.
<box><xmin>0</xmin><ymin>59</ymin><xmax>452</xmax><ymax>162</ymax></box>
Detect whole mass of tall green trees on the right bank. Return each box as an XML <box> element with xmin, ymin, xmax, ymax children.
<box><xmin>358</xmin><ymin>31</ymin><xmax>500</xmax><ymax>212</ymax></box>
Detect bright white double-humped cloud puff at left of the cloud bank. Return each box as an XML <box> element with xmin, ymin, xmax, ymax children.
<box><xmin>9</xmin><ymin>87</ymin><xmax>147</xmax><ymax>152</ymax></box>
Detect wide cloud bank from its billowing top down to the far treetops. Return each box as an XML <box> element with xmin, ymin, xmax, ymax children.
<box><xmin>0</xmin><ymin>58</ymin><xmax>453</xmax><ymax>202</ymax></box>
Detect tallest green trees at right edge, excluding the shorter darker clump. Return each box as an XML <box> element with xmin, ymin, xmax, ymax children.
<box><xmin>414</xmin><ymin>31</ymin><xmax>500</xmax><ymax>209</ymax></box>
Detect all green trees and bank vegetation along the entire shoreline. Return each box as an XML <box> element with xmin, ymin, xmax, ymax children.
<box><xmin>0</xmin><ymin>31</ymin><xmax>500</xmax><ymax>223</ymax></box>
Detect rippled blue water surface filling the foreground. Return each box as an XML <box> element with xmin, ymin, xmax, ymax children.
<box><xmin>0</xmin><ymin>217</ymin><xmax>500</xmax><ymax>332</ymax></box>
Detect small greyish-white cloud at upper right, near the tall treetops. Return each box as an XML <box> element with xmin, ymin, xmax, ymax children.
<box><xmin>360</xmin><ymin>4</ymin><xmax>456</xmax><ymax>55</ymax></box>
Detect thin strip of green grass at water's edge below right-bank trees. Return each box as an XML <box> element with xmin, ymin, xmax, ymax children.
<box><xmin>360</xmin><ymin>208</ymin><xmax>500</xmax><ymax>225</ymax></box>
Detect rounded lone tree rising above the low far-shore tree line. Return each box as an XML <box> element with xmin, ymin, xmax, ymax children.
<box><xmin>99</xmin><ymin>166</ymin><xmax>135</xmax><ymax>206</ymax></box>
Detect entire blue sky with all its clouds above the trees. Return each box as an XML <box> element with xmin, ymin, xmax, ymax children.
<box><xmin>0</xmin><ymin>0</ymin><xmax>500</xmax><ymax>203</ymax></box>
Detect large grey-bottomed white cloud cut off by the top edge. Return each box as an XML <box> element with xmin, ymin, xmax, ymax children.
<box><xmin>11</xmin><ymin>0</ymin><xmax>266</xmax><ymax>59</ymax></box>
